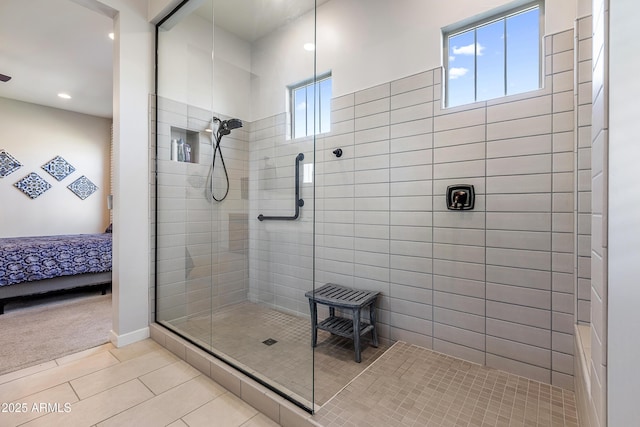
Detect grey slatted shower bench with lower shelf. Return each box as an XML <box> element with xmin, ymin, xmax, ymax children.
<box><xmin>305</xmin><ymin>283</ymin><xmax>379</xmax><ymax>363</ymax></box>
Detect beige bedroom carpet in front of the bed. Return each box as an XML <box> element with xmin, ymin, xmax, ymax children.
<box><xmin>0</xmin><ymin>292</ymin><xmax>112</xmax><ymax>375</ymax></box>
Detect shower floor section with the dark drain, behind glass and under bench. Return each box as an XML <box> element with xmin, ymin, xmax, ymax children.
<box><xmin>168</xmin><ymin>302</ymin><xmax>389</xmax><ymax>405</ymax></box>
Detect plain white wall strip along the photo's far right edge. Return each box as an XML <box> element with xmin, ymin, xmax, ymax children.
<box><xmin>594</xmin><ymin>0</ymin><xmax>640</xmax><ymax>427</ymax></box>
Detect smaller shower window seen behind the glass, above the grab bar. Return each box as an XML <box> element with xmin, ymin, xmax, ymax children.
<box><xmin>289</xmin><ymin>74</ymin><xmax>331</xmax><ymax>139</ymax></box>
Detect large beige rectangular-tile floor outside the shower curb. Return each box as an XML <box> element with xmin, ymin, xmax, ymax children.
<box><xmin>0</xmin><ymin>339</ymin><xmax>277</xmax><ymax>427</ymax></box>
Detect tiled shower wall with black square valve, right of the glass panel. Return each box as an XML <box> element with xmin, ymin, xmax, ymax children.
<box><xmin>312</xmin><ymin>31</ymin><xmax>586</xmax><ymax>388</ymax></box>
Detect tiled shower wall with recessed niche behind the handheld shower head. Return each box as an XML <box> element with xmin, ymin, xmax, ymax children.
<box><xmin>152</xmin><ymin>97</ymin><xmax>250</xmax><ymax>322</ymax></box>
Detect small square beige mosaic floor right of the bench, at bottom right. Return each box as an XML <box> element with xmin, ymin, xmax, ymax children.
<box><xmin>313</xmin><ymin>342</ymin><xmax>578</xmax><ymax>427</ymax></box>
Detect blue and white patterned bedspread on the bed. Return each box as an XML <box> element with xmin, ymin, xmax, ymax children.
<box><xmin>0</xmin><ymin>233</ymin><xmax>112</xmax><ymax>286</ymax></box>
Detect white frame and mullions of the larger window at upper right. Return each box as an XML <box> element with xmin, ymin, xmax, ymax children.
<box><xmin>442</xmin><ymin>0</ymin><xmax>544</xmax><ymax>108</ymax></box>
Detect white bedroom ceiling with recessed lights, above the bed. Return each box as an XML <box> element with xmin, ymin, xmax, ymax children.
<box><xmin>0</xmin><ymin>0</ymin><xmax>113</xmax><ymax>117</ymax></box>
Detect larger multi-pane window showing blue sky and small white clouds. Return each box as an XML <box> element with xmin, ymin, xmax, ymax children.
<box><xmin>444</xmin><ymin>2</ymin><xmax>543</xmax><ymax>107</ymax></box>
